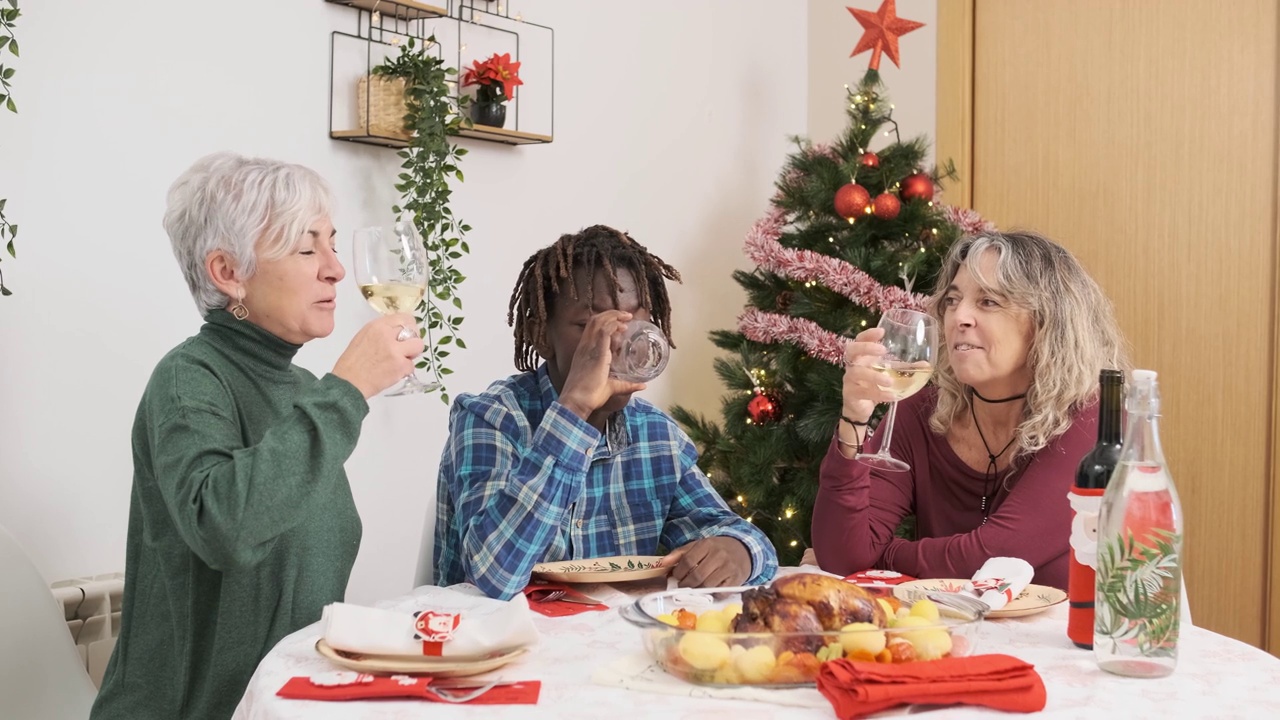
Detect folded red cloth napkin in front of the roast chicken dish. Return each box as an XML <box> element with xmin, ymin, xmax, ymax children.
<box><xmin>818</xmin><ymin>655</ymin><xmax>1044</xmax><ymax>720</ymax></box>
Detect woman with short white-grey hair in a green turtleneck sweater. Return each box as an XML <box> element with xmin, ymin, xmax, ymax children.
<box><xmin>91</xmin><ymin>154</ymin><xmax>422</xmax><ymax>720</ymax></box>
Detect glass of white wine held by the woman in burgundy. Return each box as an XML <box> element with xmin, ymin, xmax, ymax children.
<box><xmin>856</xmin><ymin>307</ymin><xmax>938</xmax><ymax>470</ymax></box>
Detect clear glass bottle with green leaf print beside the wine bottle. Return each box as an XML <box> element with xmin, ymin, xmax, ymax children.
<box><xmin>1093</xmin><ymin>370</ymin><xmax>1183</xmax><ymax>678</ymax></box>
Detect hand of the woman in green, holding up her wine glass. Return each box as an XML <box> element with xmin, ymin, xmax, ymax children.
<box><xmin>333</xmin><ymin>313</ymin><xmax>424</xmax><ymax>400</ymax></box>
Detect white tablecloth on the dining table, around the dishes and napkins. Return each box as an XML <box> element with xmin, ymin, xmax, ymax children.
<box><xmin>234</xmin><ymin>566</ymin><xmax>1280</xmax><ymax>720</ymax></box>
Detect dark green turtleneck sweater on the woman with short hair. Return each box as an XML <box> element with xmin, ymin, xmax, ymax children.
<box><xmin>91</xmin><ymin>310</ymin><xmax>369</xmax><ymax>720</ymax></box>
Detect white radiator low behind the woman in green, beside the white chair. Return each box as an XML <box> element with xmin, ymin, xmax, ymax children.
<box><xmin>51</xmin><ymin>573</ymin><xmax>124</xmax><ymax>685</ymax></box>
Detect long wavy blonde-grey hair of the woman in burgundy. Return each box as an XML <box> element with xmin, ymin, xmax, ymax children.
<box><xmin>927</xmin><ymin>232</ymin><xmax>1129</xmax><ymax>457</ymax></box>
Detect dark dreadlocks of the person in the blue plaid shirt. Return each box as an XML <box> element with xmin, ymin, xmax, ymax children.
<box><xmin>507</xmin><ymin>225</ymin><xmax>680</xmax><ymax>372</ymax></box>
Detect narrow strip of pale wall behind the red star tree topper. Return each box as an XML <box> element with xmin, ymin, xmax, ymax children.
<box><xmin>808</xmin><ymin>0</ymin><xmax>938</xmax><ymax>161</ymax></box>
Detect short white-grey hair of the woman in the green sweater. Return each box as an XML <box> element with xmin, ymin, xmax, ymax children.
<box><xmin>164</xmin><ymin>152</ymin><xmax>333</xmax><ymax>315</ymax></box>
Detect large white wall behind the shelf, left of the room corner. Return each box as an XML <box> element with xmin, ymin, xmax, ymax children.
<box><xmin>0</xmin><ymin>0</ymin><xmax>808</xmax><ymax>602</ymax></box>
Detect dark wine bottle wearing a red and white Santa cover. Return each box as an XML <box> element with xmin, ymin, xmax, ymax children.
<box><xmin>1066</xmin><ymin>370</ymin><xmax>1124</xmax><ymax>650</ymax></box>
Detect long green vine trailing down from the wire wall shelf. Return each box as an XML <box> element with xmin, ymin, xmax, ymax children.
<box><xmin>372</xmin><ymin>36</ymin><xmax>471</xmax><ymax>404</ymax></box>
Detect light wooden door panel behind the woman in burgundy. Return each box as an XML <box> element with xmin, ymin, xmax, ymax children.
<box><xmin>962</xmin><ymin>0</ymin><xmax>1277</xmax><ymax>646</ymax></box>
